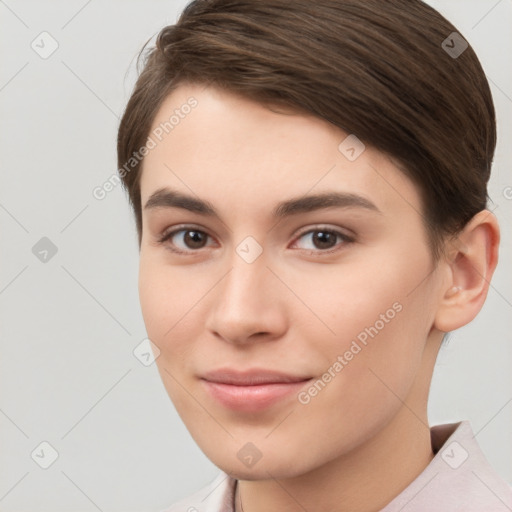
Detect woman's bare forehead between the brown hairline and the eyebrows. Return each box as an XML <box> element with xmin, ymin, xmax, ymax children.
<box><xmin>140</xmin><ymin>84</ymin><xmax>420</xmax><ymax>219</ymax></box>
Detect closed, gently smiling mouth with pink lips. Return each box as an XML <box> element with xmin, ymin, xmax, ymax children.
<box><xmin>200</xmin><ymin>369</ymin><xmax>312</xmax><ymax>412</ymax></box>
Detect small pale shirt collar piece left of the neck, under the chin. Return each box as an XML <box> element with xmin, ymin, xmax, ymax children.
<box><xmin>160</xmin><ymin>472</ymin><xmax>236</xmax><ymax>512</ymax></box>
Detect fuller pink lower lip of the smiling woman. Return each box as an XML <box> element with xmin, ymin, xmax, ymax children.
<box><xmin>202</xmin><ymin>379</ymin><xmax>311</xmax><ymax>412</ymax></box>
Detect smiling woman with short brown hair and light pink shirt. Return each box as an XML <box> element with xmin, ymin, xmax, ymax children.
<box><xmin>118</xmin><ymin>0</ymin><xmax>512</xmax><ymax>512</ymax></box>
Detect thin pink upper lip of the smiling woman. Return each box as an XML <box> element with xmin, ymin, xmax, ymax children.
<box><xmin>201</xmin><ymin>368</ymin><xmax>311</xmax><ymax>386</ymax></box>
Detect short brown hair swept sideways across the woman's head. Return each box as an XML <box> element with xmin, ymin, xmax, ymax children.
<box><xmin>117</xmin><ymin>0</ymin><xmax>496</xmax><ymax>259</ymax></box>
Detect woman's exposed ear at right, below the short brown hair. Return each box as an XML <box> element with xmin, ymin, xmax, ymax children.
<box><xmin>434</xmin><ymin>210</ymin><xmax>500</xmax><ymax>332</ymax></box>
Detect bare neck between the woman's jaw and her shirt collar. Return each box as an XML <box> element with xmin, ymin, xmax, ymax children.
<box><xmin>235</xmin><ymin>406</ymin><xmax>434</xmax><ymax>512</ymax></box>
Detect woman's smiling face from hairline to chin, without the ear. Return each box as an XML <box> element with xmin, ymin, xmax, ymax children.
<box><xmin>139</xmin><ymin>85</ymin><xmax>446</xmax><ymax>479</ymax></box>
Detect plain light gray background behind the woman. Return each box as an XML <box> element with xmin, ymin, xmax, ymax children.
<box><xmin>0</xmin><ymin>0</ymin><xmax>512</xmax><ymax>512</ymax></box>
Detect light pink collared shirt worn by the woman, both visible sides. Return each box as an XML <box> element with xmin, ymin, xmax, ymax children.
<box><xmin>161</xmin><ymin>421</ymin><xmax>512</xmax><ymax>512</ymax></box>
